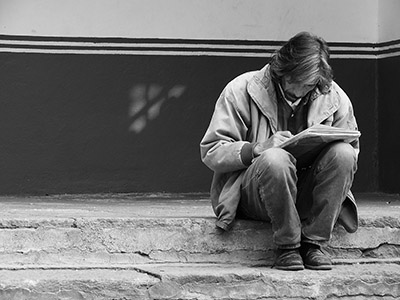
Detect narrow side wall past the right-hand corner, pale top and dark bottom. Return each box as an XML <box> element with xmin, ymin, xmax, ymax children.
<box><xmin>379</xmin><ymin>0</ymin><xmax>400</xmax><ymax>193</ymax></box>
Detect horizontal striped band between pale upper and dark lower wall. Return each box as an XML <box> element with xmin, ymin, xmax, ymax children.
<box><xmin>0</xmin><ymin>35</ymin><xmax>400</xmax><ymax>59</ymax></box>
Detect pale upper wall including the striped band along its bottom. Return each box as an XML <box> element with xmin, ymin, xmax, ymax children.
<box><xmin>0</xmin><ymin>0</ymin><xmax>400</xmax><ymax>58</ymax></box>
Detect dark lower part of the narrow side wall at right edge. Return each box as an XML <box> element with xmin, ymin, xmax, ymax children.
<box><xmin>379</xmin><ymin>56</ymin><xmax>400</xmax><ymax>193</ymax></box>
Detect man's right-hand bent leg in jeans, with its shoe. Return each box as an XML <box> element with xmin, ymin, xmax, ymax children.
<box><xmin>297</xmin><ymin>142</ymin><xmax>357</xmax><ymax>269</ymax></box>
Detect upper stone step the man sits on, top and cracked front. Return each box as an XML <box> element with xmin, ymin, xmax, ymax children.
<box><xmin>0</xmin><ymin>194</ymin><xmax>400</xmax><ymax>267</ymax></box>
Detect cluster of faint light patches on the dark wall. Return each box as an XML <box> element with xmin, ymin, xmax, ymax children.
<box><xmin>129</xmin><ymin>84</ymin><xmax>186</xmax><ymax>134</ymax></box>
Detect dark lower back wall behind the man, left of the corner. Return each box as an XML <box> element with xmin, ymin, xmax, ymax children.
<box><xmin>0</xmin><ymin>53</ymin><xmax>378</xmax><ymax>194</ymax></box>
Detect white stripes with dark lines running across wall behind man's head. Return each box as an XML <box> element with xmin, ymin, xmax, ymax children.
<box><xmin>0</xmin><ymin>39</ymin><xmax>400</xmax><ymax>59</ymax></box>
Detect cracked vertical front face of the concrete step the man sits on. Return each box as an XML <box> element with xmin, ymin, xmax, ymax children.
<box><xmin>0</xmin><ymin>212</ymin><xmax>400</xmax><ymax>264</ymax></box>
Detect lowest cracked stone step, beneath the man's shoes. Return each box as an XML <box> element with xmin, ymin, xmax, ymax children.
<box><xmin>0</xmin><ymin>263</ymin><xmax>400</xmax><ymax>300</ymax></box>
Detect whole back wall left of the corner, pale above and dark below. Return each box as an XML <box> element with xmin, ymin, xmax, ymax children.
<box><xmin>0</xmin><ymin>0</ymin><xmax>392</xmax><ymax>194</ymax></box>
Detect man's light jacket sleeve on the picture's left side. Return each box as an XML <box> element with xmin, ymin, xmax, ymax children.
<box><xmin>200</xmin><ymin>84</ymin><xmax>251</xmax><ymax>173</ymax></box>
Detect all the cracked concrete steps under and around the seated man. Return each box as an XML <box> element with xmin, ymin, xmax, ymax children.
<box><xmin>0</xmin><ymin>194</ymin><xmax>400</xmax><ymax>300</ymax></box>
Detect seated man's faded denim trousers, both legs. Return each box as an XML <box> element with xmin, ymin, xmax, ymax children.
<box><xmin>238</xmin><ymin>142</ymin><xmax>357</xmax><ymax>249</ymax></box>
